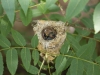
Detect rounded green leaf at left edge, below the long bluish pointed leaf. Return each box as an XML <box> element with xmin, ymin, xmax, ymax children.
<box><xmin>0</xmin><ymin>19</ymin><xmax>12</xmax><ymax>36</ymax></box>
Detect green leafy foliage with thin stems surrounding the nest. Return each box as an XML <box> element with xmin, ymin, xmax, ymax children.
<box><xmin>0</xmin><ymin>0</ymin><xmax>100</xmax><ymax>75</ymax></box>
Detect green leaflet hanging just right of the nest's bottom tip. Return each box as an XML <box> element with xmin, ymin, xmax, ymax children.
<box><xmin>55</xmin><ymin>55</ymin><xmax>67</xmax><ymax>75</ymax></box>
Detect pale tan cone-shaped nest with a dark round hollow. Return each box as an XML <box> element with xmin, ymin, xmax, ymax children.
<box><xmin>32</xmin><ymin>20</ymin><xmax>67</xmax><ymax>61</ymax></box>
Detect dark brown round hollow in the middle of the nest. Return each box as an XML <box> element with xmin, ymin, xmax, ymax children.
<box><xmin>42</xmin><ymin>27</ymin><xmax>57</xmax><ymax>40</ymax></box>
